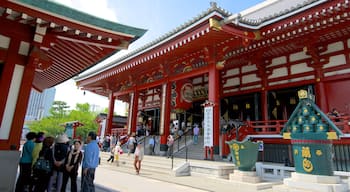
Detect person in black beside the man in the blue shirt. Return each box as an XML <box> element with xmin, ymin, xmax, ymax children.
<box><xmin>61</xmin><ymin>140</ymin><xmax>83</xmax><ymax>192</ymax></box>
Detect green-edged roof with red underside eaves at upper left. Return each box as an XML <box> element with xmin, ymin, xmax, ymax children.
<box><xmin>0</xmin><ymin>0</ymin><xmax>146</xmax><ymax>90</ymax></box>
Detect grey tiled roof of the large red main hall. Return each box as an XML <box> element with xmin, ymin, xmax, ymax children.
<box><xmin>75</xmin><ymin>0</ymin><xmax>327</xmax><ymax>82</ymax></box>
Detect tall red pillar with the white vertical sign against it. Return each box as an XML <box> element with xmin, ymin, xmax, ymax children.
<box><xmin>208</xmin><ymin>58</ymin><xmax>220</xmax><ymax>154</ymax></box>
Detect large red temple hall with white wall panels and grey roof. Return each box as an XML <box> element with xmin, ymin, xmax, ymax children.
<box><xmin>76</xmin><ymin>0</ymin><xmax>350</xmax><ymax>171</ymax></box>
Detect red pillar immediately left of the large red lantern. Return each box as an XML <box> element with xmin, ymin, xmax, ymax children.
<box><xmin>160</xmin><ymin>82</ymin><xmax>171</xmax><ymax>151</ymax></box>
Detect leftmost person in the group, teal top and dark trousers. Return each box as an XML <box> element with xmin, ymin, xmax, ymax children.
<box><xmin>15</xmin><ymin>132</ymin><xmax>36</xmax><ymax>192</ymax></box>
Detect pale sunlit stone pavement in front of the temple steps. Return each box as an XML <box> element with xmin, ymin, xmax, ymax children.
<box><xmin>76</xmin><ymin>158</ymin><xmax>272</xmax><ymax>192</ymax></box>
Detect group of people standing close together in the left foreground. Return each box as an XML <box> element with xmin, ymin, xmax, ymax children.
<box><xmin>15</xmin><ymin>132</ymin><xmax>100</xmax><ymax>192</ymax></box>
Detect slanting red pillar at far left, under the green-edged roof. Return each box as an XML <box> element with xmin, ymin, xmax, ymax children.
<box><xmin>8</xmin><ymin>57</ymin><xmax>35</xmax><ymax>149</ymax></box>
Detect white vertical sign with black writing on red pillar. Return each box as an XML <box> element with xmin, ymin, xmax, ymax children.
<box><xmin>203</xmin><ymin>106</ymin><xmax>214</xmax><ymax>147</ymax></box>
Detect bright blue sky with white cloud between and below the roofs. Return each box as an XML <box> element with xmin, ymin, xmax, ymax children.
<box><xmin>53</xmin><ymin>0</ymin><xmax>263</xmax><ymax>114</ymax></box>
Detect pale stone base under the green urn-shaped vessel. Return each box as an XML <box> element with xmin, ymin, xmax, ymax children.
<box><xmin>229</xmin><ymin>170</ymin><xmax>277</xmax><ymax>192</ymax></box>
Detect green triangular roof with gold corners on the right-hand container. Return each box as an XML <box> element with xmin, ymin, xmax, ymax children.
<box><xmin>282</xmin><ymin>90</ymin><xmax>343</xmax><ymax>140</ymax></box>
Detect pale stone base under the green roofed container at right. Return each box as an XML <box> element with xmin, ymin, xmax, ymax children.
<box><xmin>273</xmin><ymin>172</ymin><xmax>349</xmax><ymax>192</ymax></box>
